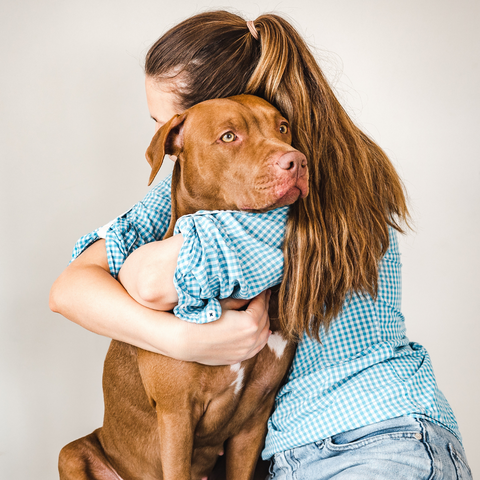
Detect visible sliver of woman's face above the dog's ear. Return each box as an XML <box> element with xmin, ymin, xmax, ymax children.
<box><xmin>145</xmin><ymin>75</ymin><xmax>182</xmax><ymax>132</ymax></box>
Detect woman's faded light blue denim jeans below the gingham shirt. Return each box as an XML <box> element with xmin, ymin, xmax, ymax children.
<box><xmin>267</xmin><ymin>417</ymin><xmax>472</xmax><ymax>480</ymax></box>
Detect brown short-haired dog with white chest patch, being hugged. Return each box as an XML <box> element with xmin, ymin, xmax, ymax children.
<box><xmin>59</xmin><ymin>95</ymin><xmax>308</xmax><ymax>480</ymax></box>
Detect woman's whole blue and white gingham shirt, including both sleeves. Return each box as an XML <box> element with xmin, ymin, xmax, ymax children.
<box><xmin>73</xmin><ymin>177</ymin><xmax>460</xmax><ymax>459</ymax></box>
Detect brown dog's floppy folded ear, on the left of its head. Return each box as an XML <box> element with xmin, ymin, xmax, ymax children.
<box><xmin>145</xmin><ymin>113</ymin><xmax>187</xmax><ymax>185</ymax></box>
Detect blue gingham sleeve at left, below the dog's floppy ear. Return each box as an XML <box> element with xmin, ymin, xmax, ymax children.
<box><xmin>72</xmin><ymin>175</ymin><xmax>172</xmax><ymax>278</ymax></box>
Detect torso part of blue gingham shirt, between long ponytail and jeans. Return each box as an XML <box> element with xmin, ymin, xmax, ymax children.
<box><xmin>262</xmin><ymin>229</ymin><xmax>460</xmax><ymax>459</ymax></box>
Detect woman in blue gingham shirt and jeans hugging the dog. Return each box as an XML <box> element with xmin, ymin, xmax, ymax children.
<box><xmin>51</xmin><ymin>12</ymin><xmax>471</xmax><ymax>479</ymax></box>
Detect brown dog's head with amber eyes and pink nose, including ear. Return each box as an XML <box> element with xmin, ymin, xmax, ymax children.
<box><xmin>146</xmin><ymin>95</ymin><xmax>308</xmax><ymax>211</ymax></box>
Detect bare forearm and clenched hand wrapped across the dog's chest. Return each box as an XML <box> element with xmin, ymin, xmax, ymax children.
<box><xmin>50</xmin><ymin>240</ymin><xmax>269</xmax><ymax>365</ymax></box>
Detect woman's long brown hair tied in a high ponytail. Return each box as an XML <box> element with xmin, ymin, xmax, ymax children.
<box><xmin>145</xmin><ymin>11</ymin><xmax>408</xmax><ymax>340</ymax></box>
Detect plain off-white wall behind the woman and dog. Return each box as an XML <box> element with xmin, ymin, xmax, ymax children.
<box><xmin>0</xmin><ymin>0</ymin><xmax>480</xmax><ymax>480</ymax></box>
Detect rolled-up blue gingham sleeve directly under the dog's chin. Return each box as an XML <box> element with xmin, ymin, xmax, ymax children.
<box><xmin>173</xmin><ymin>207</ymin><xmax>288</xmax><ymax>323</ymax></box>
